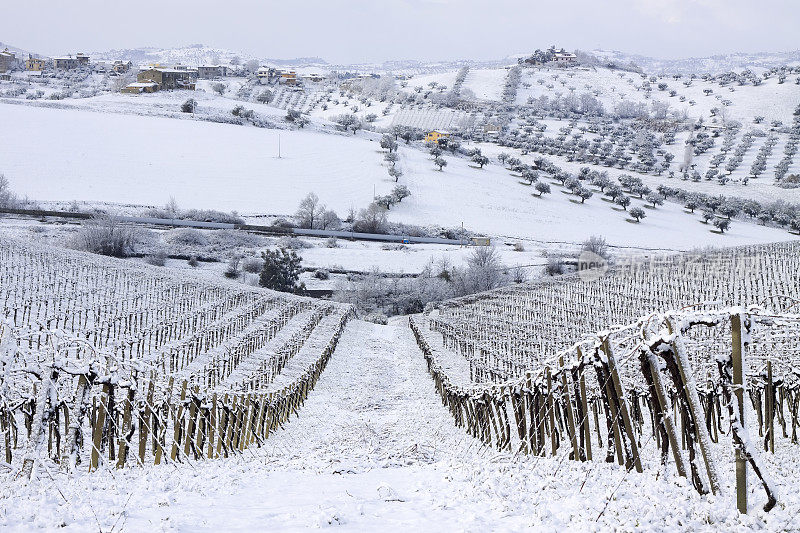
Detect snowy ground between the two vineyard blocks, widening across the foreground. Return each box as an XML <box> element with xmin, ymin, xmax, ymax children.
<box><xmin>0</xmin><ymin>319</ymin><xmax>800</xmax><ymax>532</ymax></box>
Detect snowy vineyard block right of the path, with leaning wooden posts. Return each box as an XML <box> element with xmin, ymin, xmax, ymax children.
<box><xmin>411</xmin><ymin>243</ymin><xmax>800</xmax><ymax>512</ymax></box>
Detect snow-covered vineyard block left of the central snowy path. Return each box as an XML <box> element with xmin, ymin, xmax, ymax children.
<box><xmin>0</xmin><ymin>240</ymin><xmax>352</xmax><ymax>477</ymax></box>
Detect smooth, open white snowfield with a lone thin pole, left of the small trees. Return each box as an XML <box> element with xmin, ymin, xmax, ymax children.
<box><xmin>0</xmin><ymin>101</ymin><xmax>389</xmax><ymax>213</ymax></box>
